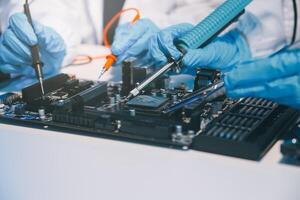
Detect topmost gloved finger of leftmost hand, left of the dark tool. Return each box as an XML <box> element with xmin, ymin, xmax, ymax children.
<box><xmin>9</xmin><ymin>13</ymin><xmax>38</xmax><ymax>46</ymax></box>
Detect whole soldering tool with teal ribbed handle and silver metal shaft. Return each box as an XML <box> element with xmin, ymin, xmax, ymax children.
<box><xmin>126</xmin><ymin>0</ymin><xmax>252</xmax><ymax>100</ymax></box>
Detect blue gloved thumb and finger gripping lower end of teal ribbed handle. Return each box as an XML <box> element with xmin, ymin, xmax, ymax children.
<box><xmin>157</xmin><ymin>23</ymin><xmax>193</xmax><ymax>60</ymax></box>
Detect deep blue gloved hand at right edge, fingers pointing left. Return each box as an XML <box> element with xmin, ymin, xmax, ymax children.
<box><xmin>224</xmin><ymin>51</ymin><xmax>300</xmax><ymax>108</ymax></box>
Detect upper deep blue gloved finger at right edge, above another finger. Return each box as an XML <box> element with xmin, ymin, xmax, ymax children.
<box><xmin>225</xmin><ymin>51</ymin><xmax>300</xmax><ymax>88</ymax></box>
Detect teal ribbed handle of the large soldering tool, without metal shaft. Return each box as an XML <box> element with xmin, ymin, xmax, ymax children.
<box><xmin>175</xmin><ymin>0</ymin><xmax>252</xmax><ymax>54</ymax></box>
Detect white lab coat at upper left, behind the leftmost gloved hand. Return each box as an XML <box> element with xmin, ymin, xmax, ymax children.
<box><xmin>1</xmin><ymin>0</ymin><xmax>95</xmax><ymax>64</ymax></box>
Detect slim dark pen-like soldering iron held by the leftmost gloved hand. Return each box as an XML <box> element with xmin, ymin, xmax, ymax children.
<box><xmin>24</xmin><ymin>0</ymin><xmax>45</xmax><ymax>96</ymax></box>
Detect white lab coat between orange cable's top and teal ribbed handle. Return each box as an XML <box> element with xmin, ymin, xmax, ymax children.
<box><xmin>121</xmin><ymin>0</ymin><xmax>223</xmax><ymax>28</ymax></box>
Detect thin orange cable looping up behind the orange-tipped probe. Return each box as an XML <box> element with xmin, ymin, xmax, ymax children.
<box><xmin>72</xmin><ymin>8</ymin><xmax>141</xmax><ymax>65</ymax></box>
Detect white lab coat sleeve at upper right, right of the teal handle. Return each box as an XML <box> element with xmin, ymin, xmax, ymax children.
<box><xmin>237</xmin><ymin>0</ymin><xmax>293</xmax><ymax>58</ymax></box>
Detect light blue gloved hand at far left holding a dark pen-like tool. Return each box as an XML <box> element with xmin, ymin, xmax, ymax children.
<box><xmin>0</xmin><ymin>13</ymin><xmax>66</xmax><ymax>77</ymax></box>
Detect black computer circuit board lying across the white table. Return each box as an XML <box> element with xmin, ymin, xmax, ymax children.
<box><xmin>0</xmin><ymin>74</ymin><xmax>298</xmax><ymax>160</ymax></box>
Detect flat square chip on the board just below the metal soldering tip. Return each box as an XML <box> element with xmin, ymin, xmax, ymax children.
<box><xmin>127</xmin><ymin>95</ymin><xmax>168</xmax><ymax>108</ymax></box>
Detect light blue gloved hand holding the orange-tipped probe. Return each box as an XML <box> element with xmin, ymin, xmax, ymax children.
<box><xmin>111</xmin><ymin>19</ymin><xmax>160</xmax><ymax>64</ymax></box>
